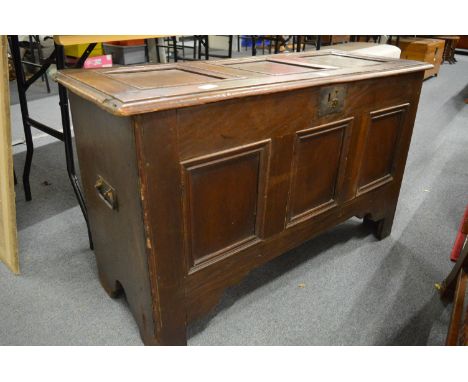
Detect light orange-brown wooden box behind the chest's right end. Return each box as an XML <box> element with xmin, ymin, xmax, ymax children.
<box><xmin>398</xmin><ymin>37</ymin><xmax>445</xmax><ymax>79</ymax></box>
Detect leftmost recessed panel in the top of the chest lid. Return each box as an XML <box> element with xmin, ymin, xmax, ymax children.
<box><xmin>108</xmin><ymin>68</ymin><xmax>223</xmax><ymax>89</ymax></box>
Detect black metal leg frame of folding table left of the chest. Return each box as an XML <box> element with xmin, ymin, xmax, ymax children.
<box><xmin>8</xmin><ymin>35</ymin><xmax>96</xmax><ymax>249</ymax></box>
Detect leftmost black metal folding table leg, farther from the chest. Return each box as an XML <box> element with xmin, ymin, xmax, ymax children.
<box><xmin>9</xmin><ymin>36</ymin><xmax>34</xmax><ymax>201</ymax></box>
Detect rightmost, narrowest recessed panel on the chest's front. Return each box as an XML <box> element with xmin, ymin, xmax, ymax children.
<box><xmin>357</xmin><ymin>104</ymin><xmax>409</xmax><ymax>195</ymax></box>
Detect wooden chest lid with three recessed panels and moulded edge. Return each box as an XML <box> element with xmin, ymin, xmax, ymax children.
<box><xmin>56</xmin><ymin>50</ymin><xmax>432</xmax><ymax>116</ymax></box>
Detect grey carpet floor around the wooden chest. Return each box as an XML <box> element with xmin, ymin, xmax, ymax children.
<box><xmin>0</xmin><ymin>56</ymin><xmax>468</xmax><ymax>345</ymax></box>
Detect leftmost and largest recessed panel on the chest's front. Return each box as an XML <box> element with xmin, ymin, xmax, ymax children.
<box><xmin>182</xmin><ymin>140</ymin><xmax>270</xmax><ymax>270</ymax></box>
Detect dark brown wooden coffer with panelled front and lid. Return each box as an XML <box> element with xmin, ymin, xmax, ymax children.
<box><xmin>58</xmin><ymin>51</ymin><xmax>431</xmax><ymax>344</ymax></box>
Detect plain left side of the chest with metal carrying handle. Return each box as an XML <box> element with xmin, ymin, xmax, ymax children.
<box><xmin>70</xmin><ymin>93</ymin><xmax>154</xmax><ymax>338</ymax></box>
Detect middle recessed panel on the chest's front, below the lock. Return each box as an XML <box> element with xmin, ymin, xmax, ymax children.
<box><xmin>287</xmin><ymin>118</ymin><xmax>352</xmax><ymax>225</ymax></box>
